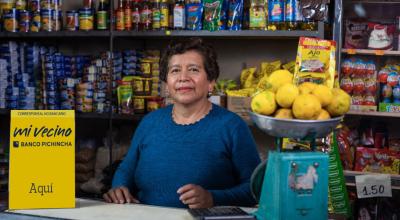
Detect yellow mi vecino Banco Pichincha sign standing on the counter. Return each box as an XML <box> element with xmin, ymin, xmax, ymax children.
<box><xmin>9</xmin><ymin>110</ymin><xmax>75</xmax><ymax>209</ymax></box>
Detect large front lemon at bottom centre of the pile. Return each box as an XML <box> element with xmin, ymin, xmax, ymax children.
<box><xmin>292</xmin><ymin>94</ymin><xmax>321</xmax><ymax>120</ymax></box>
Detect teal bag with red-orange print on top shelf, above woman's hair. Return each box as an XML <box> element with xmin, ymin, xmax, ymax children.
<box><xmin>203</xmin><ymin>0</ymin><xmax>222</xmax><ymax>31</ymax></box>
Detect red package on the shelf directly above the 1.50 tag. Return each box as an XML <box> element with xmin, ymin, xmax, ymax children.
<box><xmin>354</xmin><ymin>147</ymin><xmax>400</xmax><ymax>174</ymax></box>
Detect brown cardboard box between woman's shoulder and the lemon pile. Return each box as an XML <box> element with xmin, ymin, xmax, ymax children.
<box><xmin>227</xmin><ymin>96</ymin><xmax>253</xmax><ymax>124</ymax></box>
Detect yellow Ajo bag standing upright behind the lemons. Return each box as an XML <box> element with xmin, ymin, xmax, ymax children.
<box><xmin>294</xmin><ymin>37</ymin><xmax>336</xmax><ymax>88</ymax></box>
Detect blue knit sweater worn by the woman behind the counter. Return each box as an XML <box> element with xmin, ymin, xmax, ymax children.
<box><xmin>112</xmin><ymin>105</ymin><xmax>260</xmax><ymax>208</ymax></box>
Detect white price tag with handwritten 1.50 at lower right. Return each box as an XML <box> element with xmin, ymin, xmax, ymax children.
<box><xmin>356</xmin><ymin>174</ymin><xmax>392</xmax><ymax>199</ymax></box>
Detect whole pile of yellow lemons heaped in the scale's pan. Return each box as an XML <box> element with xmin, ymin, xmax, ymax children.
<box><xmin>251</xmin><ymin>70</ymin><xmax>351</xmax><ymax>120</ymax></box>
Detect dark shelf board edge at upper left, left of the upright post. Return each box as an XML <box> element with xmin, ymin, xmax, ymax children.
<box><xmin>0</xmin><ymin>30</ymin><xmax>111</xmax><ymax>38</ymax></box>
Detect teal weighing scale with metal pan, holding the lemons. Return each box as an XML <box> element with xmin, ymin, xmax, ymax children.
<box><xmin>249</xmin><ymin>112</ymin><xmax>343</xmax><ymax>220</ymax></box>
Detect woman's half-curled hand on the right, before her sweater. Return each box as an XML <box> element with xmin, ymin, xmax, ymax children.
<box><xmin>178</xmin><ymin>184</ymin><xmax>214</xmax><ymax>209</ymax></box>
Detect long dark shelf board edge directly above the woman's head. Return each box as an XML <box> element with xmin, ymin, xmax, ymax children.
<box><xmin>113</xmin><ymin>30</ymin><xmax>323</xmax><ymax>38</ymax></box>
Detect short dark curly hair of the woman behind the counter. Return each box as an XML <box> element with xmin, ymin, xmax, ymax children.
<box><xmin>160</xmin><ymin>37</ymin><xmax>219</xmax><ymax>82</ymax></box>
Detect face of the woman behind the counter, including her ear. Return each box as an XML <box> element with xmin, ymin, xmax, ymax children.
<box><xmin>167</xmin><ymin>51</ymin><xmax>215</xmax><ymax>105</ymax></box>
